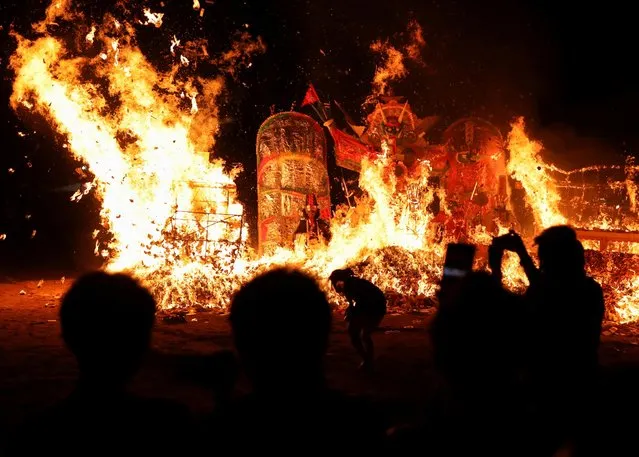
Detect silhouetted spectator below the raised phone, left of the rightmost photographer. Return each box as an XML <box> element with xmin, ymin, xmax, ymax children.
<box><xmin>428</xmin><ymin>272</ymin><xmax>525</xmax><ymax>455</ymax></box>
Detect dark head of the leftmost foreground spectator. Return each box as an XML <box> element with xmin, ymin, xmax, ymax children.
<box><xmin>60</xmin><ymin>272</ymin><xmax>155</xmax><ymax>386</ymax></box>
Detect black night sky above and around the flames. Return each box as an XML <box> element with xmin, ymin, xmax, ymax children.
<box><xmin>0</xmin><ymin>0</ymin><xmax>639</xmax><ymax>269</ymax></box>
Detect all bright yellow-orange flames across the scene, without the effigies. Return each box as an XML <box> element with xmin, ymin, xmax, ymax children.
<box><xmin>11</xmin><ymin>0</ymin><xmax>639</xmax><ymax>322</ymax></box>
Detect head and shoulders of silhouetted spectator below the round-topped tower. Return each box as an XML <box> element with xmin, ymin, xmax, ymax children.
<box><xmin>218</xmin><ymin>269</ymin><xmax>383</xmax><ymax>455</ymax></box>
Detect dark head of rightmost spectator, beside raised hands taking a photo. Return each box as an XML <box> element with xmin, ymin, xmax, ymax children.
<box><xmin>535</xmin><ymin>225</ymin><xmax>586</xmax><ymax>277</ymax></box>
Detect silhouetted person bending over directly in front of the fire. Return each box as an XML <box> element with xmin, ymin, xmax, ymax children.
<box><xmin>329</xmin><ymin>268</ymin><xmax>386</xmax><ymax>369</ymax></box>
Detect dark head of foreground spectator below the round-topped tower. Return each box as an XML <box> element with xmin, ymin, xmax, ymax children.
<box><xmin>230</xmin><ymin>268</ymin><xmax>331</xmax><ymax>389</ymax></box>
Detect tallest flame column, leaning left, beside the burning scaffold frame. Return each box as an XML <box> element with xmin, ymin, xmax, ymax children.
<box><xmin>11</xmin><ymin>2</ymin><xmax>248</xmax><ymax>276</ymax></box>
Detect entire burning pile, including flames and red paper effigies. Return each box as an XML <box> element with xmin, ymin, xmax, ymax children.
<box><xmin>11</xmin><ymin>0</ymin><xmax>639</xmax><ymax>322</ymax></box>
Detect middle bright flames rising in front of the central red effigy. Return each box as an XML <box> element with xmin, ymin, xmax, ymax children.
<box><xmin>250</xmin><ymin>158</ymin><xmax>445</xmax><ymax>299</ymax></box>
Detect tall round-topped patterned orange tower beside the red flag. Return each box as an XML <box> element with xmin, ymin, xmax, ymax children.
<box><xmin>257</xmin><ymin>112</ymin><xmax>331</xmax><ymax>254</ymax></box>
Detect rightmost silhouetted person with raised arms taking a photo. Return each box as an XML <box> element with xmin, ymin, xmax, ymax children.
<box><xmin>493</xmin><ymin>226</ymin><xmax>604</xmax><ymax>448</ymax></box>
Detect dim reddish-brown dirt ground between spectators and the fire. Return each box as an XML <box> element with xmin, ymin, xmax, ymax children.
<box><xmin>0</xmin><ymin>280</ymin><xmax>639</xmax><ymax>432</ymax></box>
